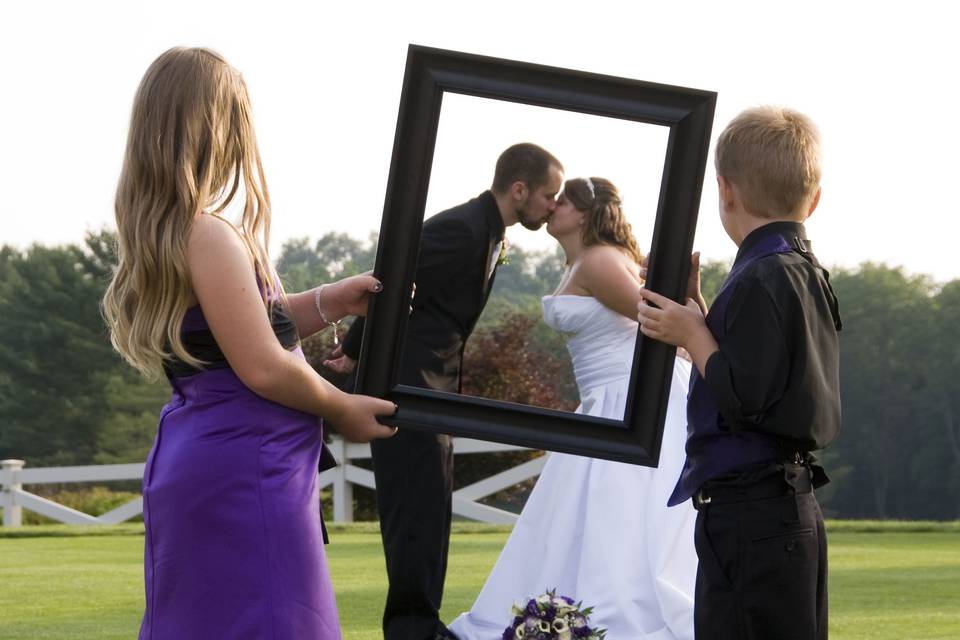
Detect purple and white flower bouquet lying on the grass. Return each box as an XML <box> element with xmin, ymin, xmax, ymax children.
<box><xmin>503</xmin><ymin>589</ymin><xmax>607</xmax><ymax>640</ymax></box>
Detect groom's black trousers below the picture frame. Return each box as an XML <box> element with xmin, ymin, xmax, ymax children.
<box><xmin>371</xmin><ymin>429</ymin><xmax>453</xmax><ymax>640</ymax></box>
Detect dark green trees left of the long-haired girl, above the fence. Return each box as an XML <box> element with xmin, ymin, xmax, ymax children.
<box><xmin>0</xmin><ymin>232</ymin><xmax>167</xmax><ymax>466</ymax></box>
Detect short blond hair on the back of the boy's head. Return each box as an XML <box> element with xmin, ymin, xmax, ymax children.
<box><xmin>715</xmin><ymin>106</ymin><xmax>820</xmax><ymax>218</ymax></box>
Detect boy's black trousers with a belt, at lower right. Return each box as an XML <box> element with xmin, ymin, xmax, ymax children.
<box><xmin>694</xmin><ymin>464</ymin><xmax>827</xmax><ymax>640</ymax></box>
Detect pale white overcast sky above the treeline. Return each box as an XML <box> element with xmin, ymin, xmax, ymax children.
<box><xmin>0</xmin><ymin>0</ymin><xmax>960</xmax><ymax>281</ymax></box>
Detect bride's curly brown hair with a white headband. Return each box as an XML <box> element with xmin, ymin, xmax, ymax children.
<box><xmin>563</xmin><ymin>177</ymin><xmax>643</xmax><ymax>264</ymax></box>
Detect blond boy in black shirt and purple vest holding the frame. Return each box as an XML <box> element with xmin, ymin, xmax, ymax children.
<box><xmin>638</xmin><ymin>107</ymin><xmax>841</xmax><ymax>640</ymax></box>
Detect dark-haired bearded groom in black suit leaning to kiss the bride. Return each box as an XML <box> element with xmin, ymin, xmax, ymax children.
<box><xmin>324</xmin><ymin>143</ymin><xmax>563</xmax><ymax>640</ymax></box>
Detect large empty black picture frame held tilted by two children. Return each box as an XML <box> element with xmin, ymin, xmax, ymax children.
<box><xmin>357</xmin><ymin>45</ymin><xmax>717</xmax><ymax>467</ymax></box>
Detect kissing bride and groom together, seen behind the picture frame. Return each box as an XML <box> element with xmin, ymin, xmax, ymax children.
<box><xmin>326</xmin><ymin>143</ymin><xmax>699</xmax><ymax>640</ymax></box>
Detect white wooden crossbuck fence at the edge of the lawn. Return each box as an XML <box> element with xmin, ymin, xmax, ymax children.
<box><xmin>0</xmin><ymin>438</ymin><xmax>549</xmax><ymax>527</ymax></box>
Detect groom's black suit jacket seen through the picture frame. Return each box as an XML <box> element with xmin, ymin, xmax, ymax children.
<box><xmin>343</xmin><ymin>191</ymin><xmax>504</xmax><ymax>393</ymax></box>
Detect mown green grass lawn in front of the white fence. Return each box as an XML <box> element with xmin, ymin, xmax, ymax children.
<box><xmin>0</xmin><ymin>522</ymin><xmax>960</xmax><ymax>640</ymax></box>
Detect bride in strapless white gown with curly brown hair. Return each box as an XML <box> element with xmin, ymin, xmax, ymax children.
<box><xmin>449</xmin><ymin>178</ymin><xmax>697</xmax><ymax>640</ymax></box>
